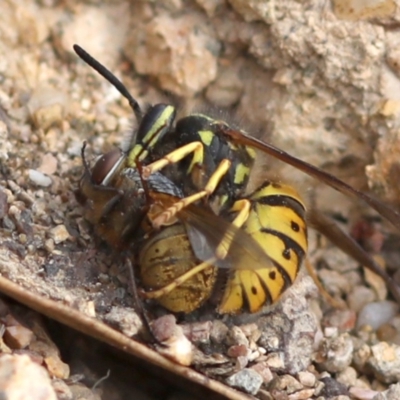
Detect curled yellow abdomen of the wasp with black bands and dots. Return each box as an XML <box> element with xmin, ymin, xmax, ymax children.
<box><xmin>219</xmin><ymin>182</ymin><xmax>307</xmax><ymax>313</ymax></box>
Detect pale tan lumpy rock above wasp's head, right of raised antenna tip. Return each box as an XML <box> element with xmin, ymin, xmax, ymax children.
<box><xmin>125</xmin><ymin>12</ymin><xmax>220</xmax><ymax>96</ymax></box>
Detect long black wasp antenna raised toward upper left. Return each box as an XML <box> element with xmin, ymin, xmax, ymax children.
<box><xmin>73</xmin><ymin>44</ymin><xmax>143</xmax><ymax>123</ymax></box>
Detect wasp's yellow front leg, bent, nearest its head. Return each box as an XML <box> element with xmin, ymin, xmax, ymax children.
<box><xmin>142</xmin><ymin>142</ymin><xmax>204</xmax><ymax>179</ymax></box>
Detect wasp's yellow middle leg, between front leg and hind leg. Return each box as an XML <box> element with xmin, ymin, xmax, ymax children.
<box><xmin>152</xmin><ymin>159</ymin><xmax>231</xmax><ymax>229</ymax></box>
